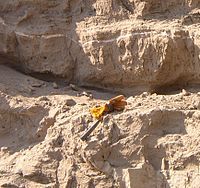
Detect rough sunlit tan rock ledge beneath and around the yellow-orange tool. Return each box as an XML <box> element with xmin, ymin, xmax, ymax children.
<box><xmin>0</xmin><ymin>65</ymin><xmax>200</xmax><ymax>188</ymax></box>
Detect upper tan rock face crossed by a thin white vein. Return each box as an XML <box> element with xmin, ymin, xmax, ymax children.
<box><xmin>0</xmin><ymin>0</ymin><xmax>200</xmax><ymax>90</ymax></box>
